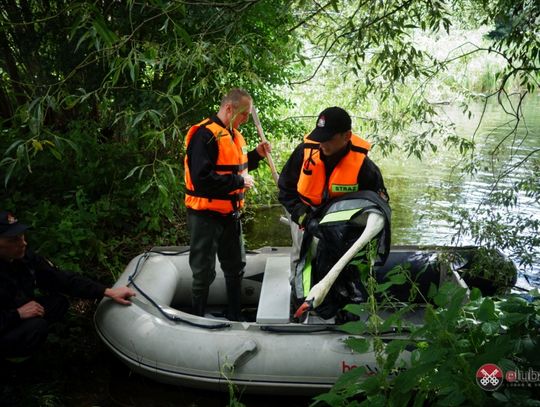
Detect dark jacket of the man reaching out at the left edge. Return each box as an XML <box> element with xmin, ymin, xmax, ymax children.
<box><xmin>0</xmin><ymin>251</ymin><xmax>107</xmax><ymax>333</ymax></box>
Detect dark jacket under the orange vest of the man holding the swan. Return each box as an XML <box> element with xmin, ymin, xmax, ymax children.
<box><xmin>278</xmin><ymin>139</ymin><xmax>388</xmax><ymax>223</ymax></box>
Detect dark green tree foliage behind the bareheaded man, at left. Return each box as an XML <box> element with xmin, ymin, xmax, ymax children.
<box><xmin>0</xmin><ymin>0</ymin><xmax>299</xmax><ymax>280</ymax></box>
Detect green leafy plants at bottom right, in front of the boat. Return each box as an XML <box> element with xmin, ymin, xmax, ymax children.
<box><xmin>312</xmin><ymin>244</ymin><xmax>540</xmax><ymax>406</ymax></box>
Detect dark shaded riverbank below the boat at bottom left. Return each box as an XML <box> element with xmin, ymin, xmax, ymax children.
<box><xmin>0</xmin><ymin>301</ymin><xmax>311</xmax><ymax>407</ymax></box>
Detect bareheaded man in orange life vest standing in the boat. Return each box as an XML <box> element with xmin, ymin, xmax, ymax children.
<box><xmin>184</xmin><ymin>89</ymin><xmax>270</xmax><ymax>321</ymax></box>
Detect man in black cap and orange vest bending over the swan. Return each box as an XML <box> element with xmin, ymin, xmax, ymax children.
<box><xmin>278</xmin><ymin>106</ymin><xmax>388</xmax><ymax>290</ymax></box>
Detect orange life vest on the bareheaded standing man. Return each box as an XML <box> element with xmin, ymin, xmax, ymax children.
<box><xmin>184</xmin><ymin>119</ymin><xmax>248</xmax><ymax>215</ymax></box>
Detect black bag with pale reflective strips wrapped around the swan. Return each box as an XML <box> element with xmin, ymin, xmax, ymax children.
<box><xmin>293</xmin><ymin>191</ymin><xmax>391</xmax><ymax>319</ymax></box>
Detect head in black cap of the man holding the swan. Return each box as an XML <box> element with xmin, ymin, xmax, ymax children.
<box><xmin>307</xmin><ymin>106</ymin><xmax>352</xmax><ymax>156</ymax></box>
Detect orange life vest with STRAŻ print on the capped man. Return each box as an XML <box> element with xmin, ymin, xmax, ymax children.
<box><xmin>297</xmin><ymin>134</ymin><xmax>371</xmax><ymax>206</ymax></box>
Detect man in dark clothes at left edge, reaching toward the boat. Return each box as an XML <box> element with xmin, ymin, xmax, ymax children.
<box><xmin>0</xmin><ymin>211</ymin><xmax>135</xmax><ymax>357</ymax></box>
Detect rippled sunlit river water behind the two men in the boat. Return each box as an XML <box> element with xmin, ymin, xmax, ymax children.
<box><xmin>245</xmin><ymin>94</ymin><xmax>540</xmax><ymax>288</ymax></box>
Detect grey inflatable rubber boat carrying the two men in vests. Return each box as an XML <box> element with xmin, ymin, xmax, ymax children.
<box><xmin>95</xmin><ymin>246</ymin><xmax>516</xmax><ymax>394</ymax></box>
